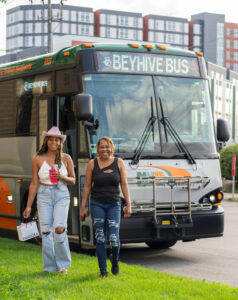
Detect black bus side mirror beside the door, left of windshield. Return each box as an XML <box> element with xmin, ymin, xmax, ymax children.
<box><xmin>74</xmin><ymin>94</ymin><xmax>93</xmax><ymax>121</ymax></box>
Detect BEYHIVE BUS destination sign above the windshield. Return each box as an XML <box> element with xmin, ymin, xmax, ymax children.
<box><xmin>97</xmin><ymin>51</ymin><xmax>200</xmax><ymax>77</ymax></box>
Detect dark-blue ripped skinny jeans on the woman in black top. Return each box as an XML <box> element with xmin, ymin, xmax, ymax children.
<box><xmin>91</xmin><ymin>200</ymin><xmax>121</xmax><ymax>272</ymax></box>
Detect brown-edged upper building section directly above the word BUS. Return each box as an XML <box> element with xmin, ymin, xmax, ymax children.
<box><xmin>143</xmin><ymin>15</ymin><xmax>189</xmax><ymax>49</ymax></box>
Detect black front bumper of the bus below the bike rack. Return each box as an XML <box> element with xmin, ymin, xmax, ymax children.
<box><xmin>120</xmin><ymin>206</ymin><xmax>224</xmax><ymax>243</ymax></box>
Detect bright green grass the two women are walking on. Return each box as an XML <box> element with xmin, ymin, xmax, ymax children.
<box><xmin>0</xmin><ymin>238</ymin><xmax>238</xmax><ymax>300</ymax></box>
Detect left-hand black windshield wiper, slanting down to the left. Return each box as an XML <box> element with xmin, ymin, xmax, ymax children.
<box><xmin>131</xmin><ymin>116</ymin><xmax>156</xmax><ymax>165</ymax></box>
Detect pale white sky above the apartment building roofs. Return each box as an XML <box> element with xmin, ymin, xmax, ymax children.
<box><xmin>0</xmin><ymin>0</ymin><xmax>238</xmax><ymax>23</ymax></box>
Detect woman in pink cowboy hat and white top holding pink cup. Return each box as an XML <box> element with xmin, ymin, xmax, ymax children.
<box><xmin>23</xmin><ymin>127</ymin><xmax>75</xmax><ymax>274</ymax></box>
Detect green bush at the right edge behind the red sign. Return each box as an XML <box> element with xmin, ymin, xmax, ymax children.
<box><xmin>220</xmin><ymin>144</ymin><xmax>238</xmax><ymax>179</ymax></box>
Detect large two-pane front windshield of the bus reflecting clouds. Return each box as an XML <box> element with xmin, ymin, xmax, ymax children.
<box><xmin>83</xmin><ymin>74</ymin><xmax>216</xmax><ymax>158</ymax></box>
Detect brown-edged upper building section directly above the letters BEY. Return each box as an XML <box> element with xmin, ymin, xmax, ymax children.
<box><xmin>94</xmin><ymin>9</ymin><xmax>143</xmax><ymax>41</ymax></box>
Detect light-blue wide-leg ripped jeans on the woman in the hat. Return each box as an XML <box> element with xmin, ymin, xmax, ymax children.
<box><xmin>37</xmin><ymin>184</ymin><xmax>71</xmax><ymax>272</ymax></box>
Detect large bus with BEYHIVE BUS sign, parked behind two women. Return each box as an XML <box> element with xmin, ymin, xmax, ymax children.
<box><xmin>0</xmin><ymin>44</ymin><xmax>229</xmax><ymax>248</ymax></box>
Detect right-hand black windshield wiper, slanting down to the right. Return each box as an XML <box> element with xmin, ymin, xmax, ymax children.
<box><xmin>160</xmin><ymin>117</ymin><xmax>196</xmax><ymax>164</ymax></box>
